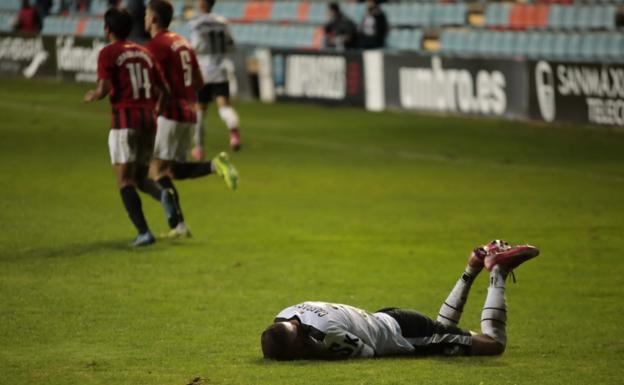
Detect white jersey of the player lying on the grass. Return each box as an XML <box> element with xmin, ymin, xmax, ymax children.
<box><xmin>276</xmin><ymin>302</ymin><xmax>415</xmax><ymax>357</ymax></box>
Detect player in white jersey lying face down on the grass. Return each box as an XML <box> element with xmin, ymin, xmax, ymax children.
<box><xmin>261</xmin><ymin>240</ymin><xmax>539</xmax><ymax>360</ymax></box>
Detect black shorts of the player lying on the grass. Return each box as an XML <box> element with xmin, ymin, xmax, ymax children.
<box><xmin>377</xmin><ymin>307</ymin><xmax>472</xmax><ymax>355</ymax></box>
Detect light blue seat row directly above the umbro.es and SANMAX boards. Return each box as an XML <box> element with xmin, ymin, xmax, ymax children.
<box><xmin>440</xmin><ymin>31</ymin><xmax>624</xmax><ymax>61</ymax></box>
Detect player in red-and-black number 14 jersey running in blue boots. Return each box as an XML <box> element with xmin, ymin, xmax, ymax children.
<box><xmin>84</xmin><ymin>8</ymin><xmax>177</xmax><ymax>246</ymax></box>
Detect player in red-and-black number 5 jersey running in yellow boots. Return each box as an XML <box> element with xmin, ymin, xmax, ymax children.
<box><xmin>145</xmin><ymin>0</ymin><xmax>238</xmax><ymax>237</ymax></box>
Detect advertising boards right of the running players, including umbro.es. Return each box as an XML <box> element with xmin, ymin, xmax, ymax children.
<box><xmin>258</xmin><ymin>49</ymin><xmax>624</xmax><ymax>126</ymax></box>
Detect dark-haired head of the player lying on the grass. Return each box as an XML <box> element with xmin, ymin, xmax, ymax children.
<box><xmin>260</xmin><ymin>322</ymin><xmax>304</xmax><ymax>361</ymax></box>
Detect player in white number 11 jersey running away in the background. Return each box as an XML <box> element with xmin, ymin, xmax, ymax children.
<box><xmin>189</xmin><ymin>0</ymin><xmax>241</xmax><ymax>153</ymax></box>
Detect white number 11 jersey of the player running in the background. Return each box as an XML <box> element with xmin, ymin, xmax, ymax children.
<box><xmin>189</xmin><ymin>13</ymin><xmax>234</xmax><ymax>83</ymax></box>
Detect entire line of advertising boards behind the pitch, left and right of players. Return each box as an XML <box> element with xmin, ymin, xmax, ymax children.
<box><xmin>0</xmin><ymin>33</ymin><xmax>624</xmax><ymax>126</ymax></box>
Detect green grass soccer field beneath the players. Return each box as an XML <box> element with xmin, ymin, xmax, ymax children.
<box><xmin>0</xmin><ymin>78</ymin><xmax>624</xmax><ymax>385</ymax></box>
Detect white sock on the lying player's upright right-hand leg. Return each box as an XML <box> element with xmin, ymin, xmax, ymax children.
<box><xmin>481</xmin><ymin>265</ymin><xmax>507</xmax><ymax>346</ymax></box>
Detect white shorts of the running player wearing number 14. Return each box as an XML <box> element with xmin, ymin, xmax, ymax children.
<box><xmin>108</xmin><ymin>128</ymin><xmax>154</xmax><ymax>164</ymax></box>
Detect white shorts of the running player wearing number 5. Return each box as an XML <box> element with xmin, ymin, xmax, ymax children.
<box><xmin>154</xmin><ymin>116</ymin><xmax>194</xmax><ymax>162</ymax></box>
